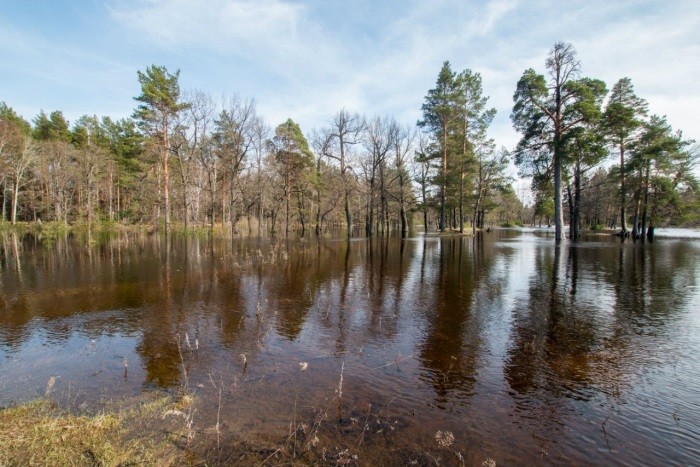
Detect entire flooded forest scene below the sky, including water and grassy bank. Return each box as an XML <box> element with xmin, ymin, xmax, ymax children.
<box><xmin>0</xmin><ymin>43</ymin><xmax>700</xmax><ymax>467</ymax></box>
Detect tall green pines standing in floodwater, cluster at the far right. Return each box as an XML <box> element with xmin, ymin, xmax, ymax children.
<box><xmin>511</xmin><ymin>42</ymin><xmax>700</xmax><ymax>240</ymax></box>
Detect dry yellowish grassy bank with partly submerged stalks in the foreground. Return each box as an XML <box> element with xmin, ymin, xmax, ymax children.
<box><xmin>0</xmin><ymin>378</ymin><xmax>495</xmax><ymax>467</ymax></box>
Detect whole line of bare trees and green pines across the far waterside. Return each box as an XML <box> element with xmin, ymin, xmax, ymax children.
<box><xmin>0</xmin><ymin>43</ymin><xmax>700</xmax><ymax>240</ymax></box>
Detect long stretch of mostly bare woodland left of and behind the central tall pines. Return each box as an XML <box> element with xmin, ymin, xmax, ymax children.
<box><xmin>0</xmin><ymin>66</ymin><xmax>512</xmax><ymax>236</ymax></box>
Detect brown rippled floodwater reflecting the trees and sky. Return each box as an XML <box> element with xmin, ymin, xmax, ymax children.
<box><xmin>0</xmin><ymin>230</ymin><xmax>700</xmax><ymax>465</ymax></box>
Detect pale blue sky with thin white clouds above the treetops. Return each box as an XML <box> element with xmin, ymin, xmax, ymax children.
<box><xmin>0</xmin><ymin>0</ymin><xmax>700</xmax><ymax>159</ymax></box>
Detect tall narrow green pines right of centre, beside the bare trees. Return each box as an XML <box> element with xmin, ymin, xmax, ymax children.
<box><xmin>418</xmin><ymin>62</ymin><xmax>516</xmax><ymax>236</ymax></box>
